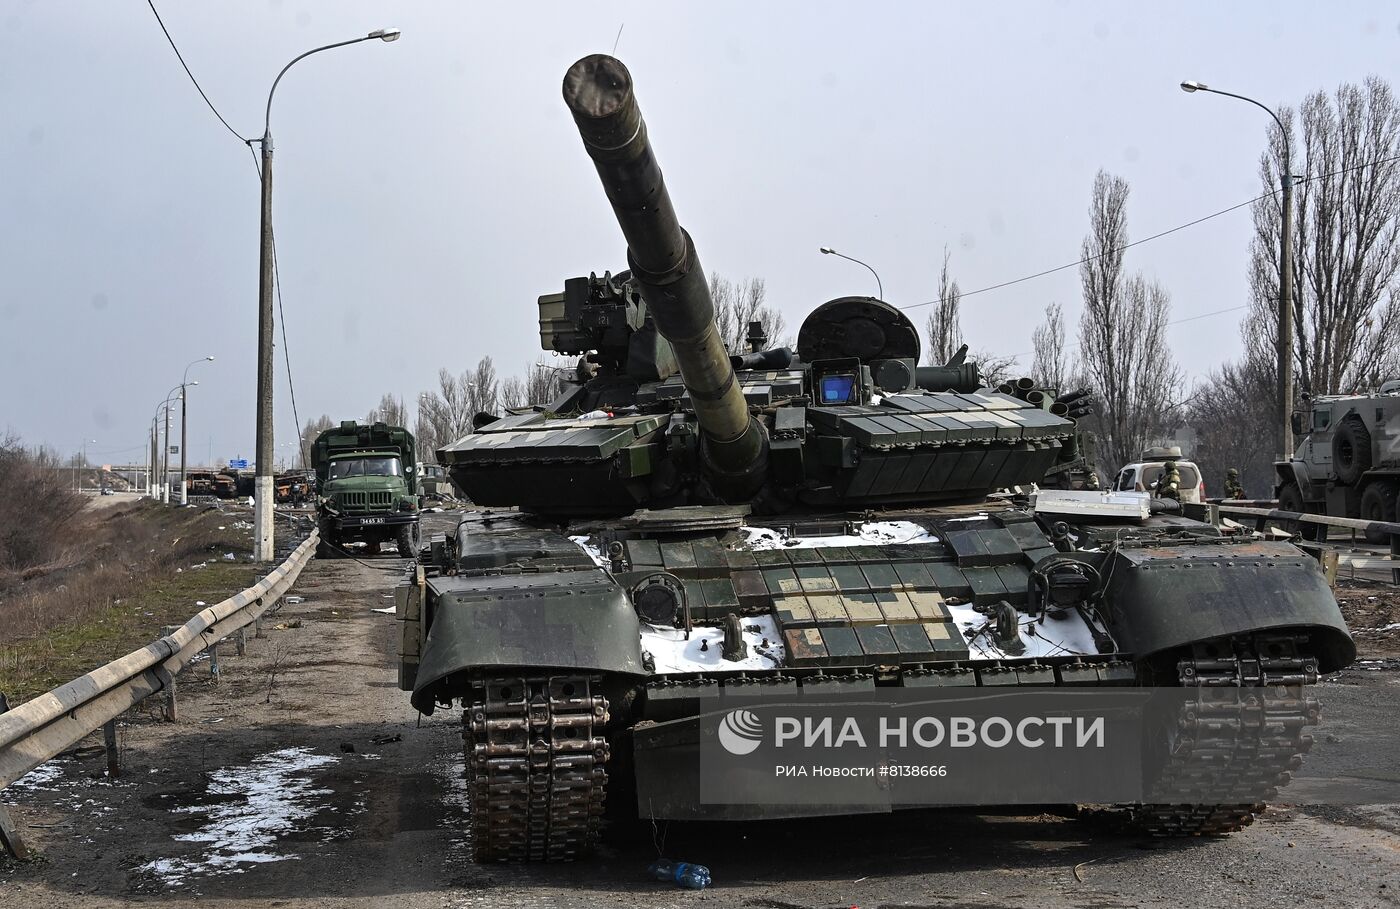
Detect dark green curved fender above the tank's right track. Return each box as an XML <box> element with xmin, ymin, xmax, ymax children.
<box><xmin>1103</xmin><ymin>542</ymin><xmax>1357</xmax><ymax>672</ymax></box>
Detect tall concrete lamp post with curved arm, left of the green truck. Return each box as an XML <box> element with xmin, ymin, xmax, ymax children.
<box><xmin>253</xmin><ymin>28</ymin><xmax>399</xmax><ymax>562</ymax></box>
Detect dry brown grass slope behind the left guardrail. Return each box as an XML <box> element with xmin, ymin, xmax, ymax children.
<box><xmin>0</xmin><ymin>503</ymin><xmax>260</xmax><ymax>706</ymax></box>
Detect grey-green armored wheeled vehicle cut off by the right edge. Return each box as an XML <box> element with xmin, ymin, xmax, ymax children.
<box><xmin>1274</xmin><ymin>380</ymin><xmax>1400</xmax><ymax>543</ymax></box>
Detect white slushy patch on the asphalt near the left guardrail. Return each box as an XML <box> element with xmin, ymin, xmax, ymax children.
<box><xmin>137</xmin><ymin>748</ymin><xmax>339</xmax><ymax>887</ymax></box>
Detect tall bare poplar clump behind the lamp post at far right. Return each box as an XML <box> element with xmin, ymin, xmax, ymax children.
<box><xmin>1246</xmin><ymin>76</ymin><xmax>1400</xmax><ymax>394</ymax></box>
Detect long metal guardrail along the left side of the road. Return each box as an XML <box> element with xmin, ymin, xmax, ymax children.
<box><xmin>0</xmin><ymin>531</ymin><xmax>316</xmax><ymax>789</ymax></box>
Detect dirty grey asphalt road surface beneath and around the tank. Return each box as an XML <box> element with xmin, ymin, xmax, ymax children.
<box><xmin>0</xmin><ymin>518</ymin><xmax>1400</xmax><ymax>909</ymax></box>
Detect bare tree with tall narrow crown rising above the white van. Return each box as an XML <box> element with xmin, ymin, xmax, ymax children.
<box><xmin>1079</xmin><ymin>171</ymin><xmax>1182</xmax><ymax>464</ymax></box>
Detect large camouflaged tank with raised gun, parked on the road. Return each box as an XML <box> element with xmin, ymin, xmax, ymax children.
<box><xmin>398</xmin><ymin>56</ymin><xmax>1355</xmax><ymax>861</ymax></box>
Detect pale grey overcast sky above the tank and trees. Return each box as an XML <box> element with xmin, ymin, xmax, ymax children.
<box><xmin>0</xmin><ymin>0</ymin><xmax>1400</xmax><ymax>462</ymax></box>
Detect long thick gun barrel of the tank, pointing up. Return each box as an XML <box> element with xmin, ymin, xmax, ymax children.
<box><xmin>564</xmin><ymin>53</ymin><xmax>767</xmax><ymax>489</ymax></box>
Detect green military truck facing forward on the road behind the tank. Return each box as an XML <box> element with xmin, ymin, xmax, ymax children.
<box><xmin>311</xmin><ymin>420</ymin><xmax>420</xmax><ymax>559</ymax></box>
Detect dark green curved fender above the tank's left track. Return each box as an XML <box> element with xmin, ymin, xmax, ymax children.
<box><xmin>412</xmin><ymin>569</ymin><xmax>645</xmax><ymax>713</ymax></box>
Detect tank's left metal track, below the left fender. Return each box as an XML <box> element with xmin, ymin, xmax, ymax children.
<box><xmin>462</xmin><ymin>675</ymin><xmax>608</xmax><ymax>863</ymax></box>
